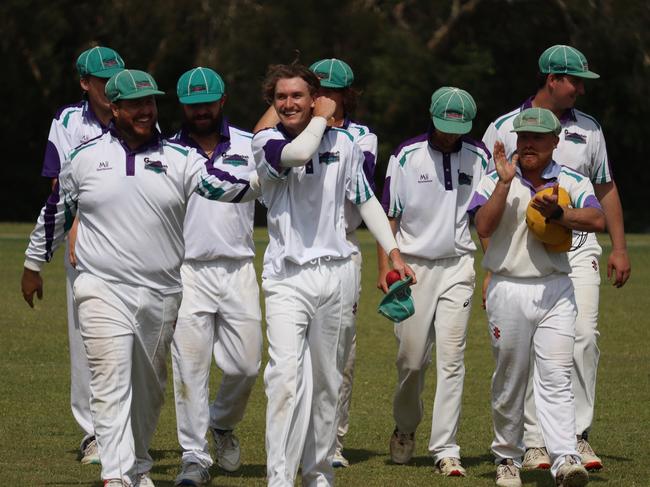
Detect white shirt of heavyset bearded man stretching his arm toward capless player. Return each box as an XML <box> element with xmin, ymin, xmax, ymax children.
<box><xmin>25</xmin><ymin>130</ymin><xmax>252</xmax><ymax>292</ymax></box>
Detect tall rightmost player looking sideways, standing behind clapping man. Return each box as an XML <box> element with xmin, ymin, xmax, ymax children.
<box><xmin>483</xmin><ymin>45</ymin><xmax>630</xmax><ymax>470</ymax></box>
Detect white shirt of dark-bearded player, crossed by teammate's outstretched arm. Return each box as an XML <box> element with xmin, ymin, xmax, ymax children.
<box><xmin>170</xmin><ymin>119</ymin><xmax>255</xmax><ymax>261</ymax></box>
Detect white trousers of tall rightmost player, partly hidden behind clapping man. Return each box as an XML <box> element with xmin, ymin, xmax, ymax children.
<box><xmin>524</xmin><ymin>252</ymin><xmax>600</xmax><ymax>448</ymax></box>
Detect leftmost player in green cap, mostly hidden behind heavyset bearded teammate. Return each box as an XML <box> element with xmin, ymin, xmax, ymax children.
<box><xmin>41</xmin><ymin>46</ymin><xmax>124</xmax><ymax>464</ymax></box>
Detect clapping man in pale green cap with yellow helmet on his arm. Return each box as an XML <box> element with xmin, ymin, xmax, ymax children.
<box><xmin>469</xmin><ymin>108</ymin><xmax>605</xmax><ymax>487</ymax></box>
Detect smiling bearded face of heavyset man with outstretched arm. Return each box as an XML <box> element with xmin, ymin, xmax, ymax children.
<box><xmin>111</xmin><ymin>96</ymin><xmax>158</xmax><ymax>148</ymax></box>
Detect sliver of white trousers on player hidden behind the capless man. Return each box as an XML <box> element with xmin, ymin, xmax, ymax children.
<box><xmin>336</xmin><ymin>232</ymin><xmax>363</xmax><ymax>450</ymax></box>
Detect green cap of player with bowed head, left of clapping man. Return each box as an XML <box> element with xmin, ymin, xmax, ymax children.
<box><xmin>429</xmin><ymin>86</ymin><xmax>476</xmax><ymax>134</ymax></box>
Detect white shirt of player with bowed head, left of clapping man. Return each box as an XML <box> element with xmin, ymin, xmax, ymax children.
<box><xmin>382</xmin><ymin>132</ymin><xmax>491</xmax><ymax>259</ymax></box>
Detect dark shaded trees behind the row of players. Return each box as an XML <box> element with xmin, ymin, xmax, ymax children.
<box><xmin>0</xmin><ymin>0</ymin><xmax>650</xmax><ymax>231</ymax></box>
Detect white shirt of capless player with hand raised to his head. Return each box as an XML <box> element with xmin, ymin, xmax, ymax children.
<box><xmin>253</xmin><ymin>124</ymin><xmax>373</xmax><ymax>278</ymax></box>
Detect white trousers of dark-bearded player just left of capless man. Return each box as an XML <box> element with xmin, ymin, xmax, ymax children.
<box><xmin>172</xmin><ymin>258</ymin><xmax>262</xmax><ymax>468</ymax></box>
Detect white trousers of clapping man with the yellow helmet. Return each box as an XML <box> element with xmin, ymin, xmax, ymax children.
<box><xmin>486</xmin><ymin>274</ymin><xmax>580</xmax><ymax>477</ymax></box>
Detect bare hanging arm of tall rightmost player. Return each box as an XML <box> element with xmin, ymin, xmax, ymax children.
<box><xmin>594</xmin><ymin>181</ymin><xmax>631</xmax><ymax>287</ymax></box>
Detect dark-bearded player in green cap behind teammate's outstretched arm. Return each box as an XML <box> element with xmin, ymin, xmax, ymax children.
<box><xmin>171</xmin><ymin>67</ymin><xmax>262</xmax><ymax>486</ymax></box>
